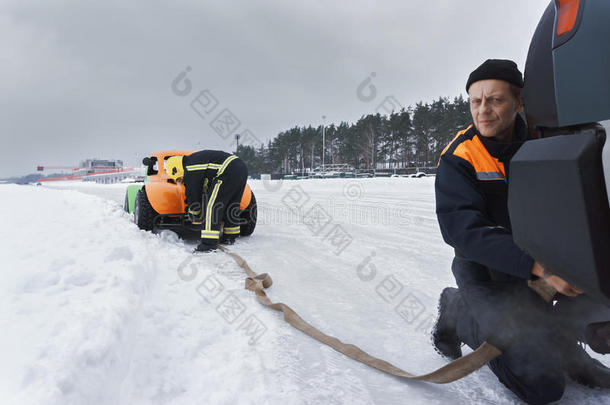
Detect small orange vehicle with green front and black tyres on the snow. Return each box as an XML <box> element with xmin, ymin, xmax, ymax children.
<box><xmin>124</xmin><ymin>150</ymin><xmax>257</xmax><ymax>238</ymax></box>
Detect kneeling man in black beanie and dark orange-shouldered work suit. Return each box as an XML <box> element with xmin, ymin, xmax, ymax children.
<box><xmin>432</xmin><ymin>60</ymin><xmax>610</xmax><ymax>404</ymax></box>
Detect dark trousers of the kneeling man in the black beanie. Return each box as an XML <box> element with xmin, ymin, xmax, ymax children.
<box><xmin>451</xmin><ymin>257</ymin><xmax>610</xmax><ymax>404</ymax></box>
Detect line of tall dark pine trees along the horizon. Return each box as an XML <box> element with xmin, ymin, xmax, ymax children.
<box><xmin>237</xmin><ymin>95</ymin><xmax>471</xmax><ymax>174</ymax></box>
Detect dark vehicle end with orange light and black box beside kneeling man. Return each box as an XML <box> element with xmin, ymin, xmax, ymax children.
<box><xmin>508</xmin><ymin>0</ymin><xmax>610</xmax><ymax>305</ymax></box>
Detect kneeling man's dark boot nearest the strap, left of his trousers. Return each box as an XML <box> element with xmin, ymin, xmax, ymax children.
<box><xmin>432</xmin><ymin>287</ymin><xmax>462</xmax><ymax>360</ymax></box>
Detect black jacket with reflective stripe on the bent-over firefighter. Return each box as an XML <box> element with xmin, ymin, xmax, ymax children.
<box><xmin>182</xmin><ymin>150</ymin><xmax>238</xmax><ymax>210</ymax></box>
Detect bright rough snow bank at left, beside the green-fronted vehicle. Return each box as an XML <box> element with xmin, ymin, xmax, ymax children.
<box><xmin>0</xmin><ymin>185</ymin><xmax>160</xmax><ymax>403</ymax></box>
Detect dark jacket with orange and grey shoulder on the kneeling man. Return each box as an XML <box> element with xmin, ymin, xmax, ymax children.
<box><xmin>435</xmin><ymin>116</ymin><xmax>534</xmax><ymax>279</ymax></box>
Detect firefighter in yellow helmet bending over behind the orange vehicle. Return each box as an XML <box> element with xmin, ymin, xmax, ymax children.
<box><xmin>165</xmin><ymin>150</ymin><xmax>248</xmax><ymax>252</ymax></box>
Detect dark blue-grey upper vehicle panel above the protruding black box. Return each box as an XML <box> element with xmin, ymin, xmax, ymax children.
<box><xmin>523</xmin><ymin>0</ymin><xmax>610</xmax><ymax>128</ymax></box>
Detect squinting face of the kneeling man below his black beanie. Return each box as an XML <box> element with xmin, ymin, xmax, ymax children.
<box><xmin>468</xmin><ymin>79</ymin><xmax>523</xmax><ymax>138</ymax></box>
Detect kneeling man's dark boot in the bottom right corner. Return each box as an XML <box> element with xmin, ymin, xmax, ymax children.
<box><xmin>561</xmin><ymin>342</ymin><xmax>610</xmax><ymax>388</ymax></box>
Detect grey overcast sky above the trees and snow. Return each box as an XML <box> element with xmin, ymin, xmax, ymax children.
<box><xmin>0</xmin><ymin>0</ymin><xmax>549</xmax><ymax>177</ymax></box>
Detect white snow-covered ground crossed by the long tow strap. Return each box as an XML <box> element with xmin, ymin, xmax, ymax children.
<box><xmin>0</xmin><ymin>178</ymin><xmax>610</xmax><ymax>404</ymax></box>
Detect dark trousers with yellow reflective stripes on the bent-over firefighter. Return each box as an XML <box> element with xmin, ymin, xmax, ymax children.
<box><xmin>201</xmin><ymin>159</ymin><xmax>248</xmax><ymax>244</ymax></box>
